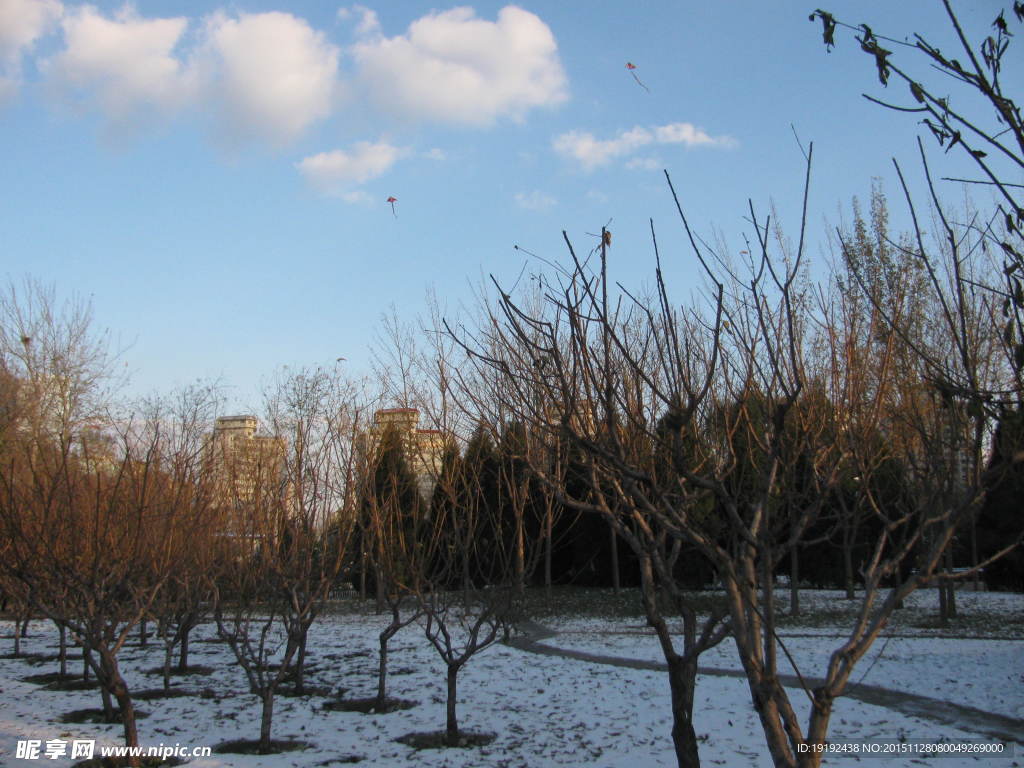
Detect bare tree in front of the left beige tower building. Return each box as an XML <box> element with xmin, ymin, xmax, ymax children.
<box><xmin>210</xmin><ymin>369</ymin><xmax>362</xmax><ymax>754</ymax></box>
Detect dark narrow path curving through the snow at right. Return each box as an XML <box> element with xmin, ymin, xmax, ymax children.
<box><xmin>508</xmin><ymin>622</ymin><xmax>1024</xmax><ymax>743</ymax></box>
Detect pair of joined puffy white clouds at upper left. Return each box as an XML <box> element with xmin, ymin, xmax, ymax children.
<box><xmin>40</xmin><ymin>6</ymin><xmax>340</xmax><ymax>144</ymax></box>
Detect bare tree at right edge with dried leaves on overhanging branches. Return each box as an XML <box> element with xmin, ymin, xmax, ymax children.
<box><xmin>811</xmin><ymin>0</ymin><xmax>1024</xmax><ymax>621</ymax></box>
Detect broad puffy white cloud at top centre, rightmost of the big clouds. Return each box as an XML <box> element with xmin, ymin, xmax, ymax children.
<box><xmin>352</xmin><ymin>5</ymin><xmax>567</xmax><ymax>125</ymax></box>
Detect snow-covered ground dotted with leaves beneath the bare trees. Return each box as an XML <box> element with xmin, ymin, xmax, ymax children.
<box><xmin>0</xmin><ymin>593</ymin><xmax>1024</xmax><ymax>768</ymax></box>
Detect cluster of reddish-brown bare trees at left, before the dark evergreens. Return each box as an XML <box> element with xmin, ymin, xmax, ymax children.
<box><xmin>0</xmin><ymin>280</ymin><xmax>361</xmax><ymax>757</ymax></box>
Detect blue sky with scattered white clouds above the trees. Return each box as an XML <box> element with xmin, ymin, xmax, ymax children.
<box><xmin>0</xmin><ymin>0</ymin><xmax>1021</xmax><ymax>407</ymax></box>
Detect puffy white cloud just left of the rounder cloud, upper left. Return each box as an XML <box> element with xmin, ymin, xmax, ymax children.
<box><xmin>42</xmin><ymin>5</ymin><xmax>195</xmax><ymax>125</ymax></box>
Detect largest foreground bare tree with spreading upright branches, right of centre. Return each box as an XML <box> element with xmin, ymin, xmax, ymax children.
<box><xmin>454</xmin><ymin>129</ymin><xmax>1007</xmax><ymax>765</ymax></box>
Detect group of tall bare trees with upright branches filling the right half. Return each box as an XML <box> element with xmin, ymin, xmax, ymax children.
<box><xmin>436</xmin><ymin>3</ymin><xmax>1024</xmax><ymax>766</ymax></box>
